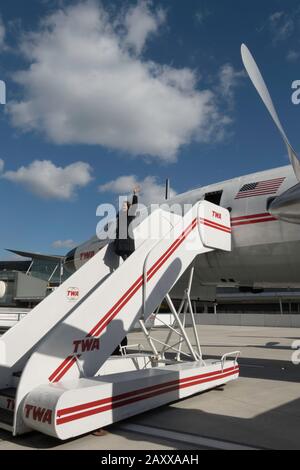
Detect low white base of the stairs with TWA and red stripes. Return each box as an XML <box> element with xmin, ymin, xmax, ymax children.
<box><xmin>23</xmin><ymin>361</ymin><xmax>239</xmax><ymax>440</ymax></box>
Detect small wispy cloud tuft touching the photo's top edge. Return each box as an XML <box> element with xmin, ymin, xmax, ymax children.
<box><xmin>124</xmin><ymin>1</ymin><xmax>165</xmax><ymax>54</ymax></box>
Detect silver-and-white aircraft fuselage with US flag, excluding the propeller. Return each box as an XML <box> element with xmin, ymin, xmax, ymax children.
<box><xmin>66</xmin><ymin>165</ymin><xmax>300</xmax><ymax>288</ymax></box>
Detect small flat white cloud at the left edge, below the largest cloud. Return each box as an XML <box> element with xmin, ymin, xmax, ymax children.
<box><xmin>1</xmin><ymin>160</ymin><xmax>92</xmax><ymax>200</ymax></box>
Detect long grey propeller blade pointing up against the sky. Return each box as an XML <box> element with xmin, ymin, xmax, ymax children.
<box><xmin>241</xmin><ymin>44</ymin><xmax>300</xmax><ymax>181</ymax></box>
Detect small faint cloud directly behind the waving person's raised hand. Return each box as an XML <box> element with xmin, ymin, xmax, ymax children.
<box><xmin>99</xmin><ymin>175</ymin><xmax>176</xmax><ymax>205</ymax></box>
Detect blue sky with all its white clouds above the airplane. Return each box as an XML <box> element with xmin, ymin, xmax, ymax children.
<box><xmin>0</xmin><ymin>0</ymin><xmax>300</xmax><ymax>259</ymax></box>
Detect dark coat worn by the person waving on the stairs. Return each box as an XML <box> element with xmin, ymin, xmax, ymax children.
<box><xmin>115</xmin><ymin>195</ymin><xmax>138</xmax><ymax>256</ymax></box>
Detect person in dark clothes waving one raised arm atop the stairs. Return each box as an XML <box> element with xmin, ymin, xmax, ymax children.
<box><xmin>115</xmin><ymin>186</ymin><xmax>140</xmax><ymax>261</ymax></box>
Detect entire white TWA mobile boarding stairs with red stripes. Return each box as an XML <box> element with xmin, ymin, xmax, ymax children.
<box><xmin>0</xmin><ymin>201</ymin><xmax>239</xmax><ymax>439</ymax></box>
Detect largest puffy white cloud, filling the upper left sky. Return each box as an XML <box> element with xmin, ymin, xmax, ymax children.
<box><xmin>7</xmin><ymin>2</ymin><xmax>229</xmax><ymax>161</ymax></box>
